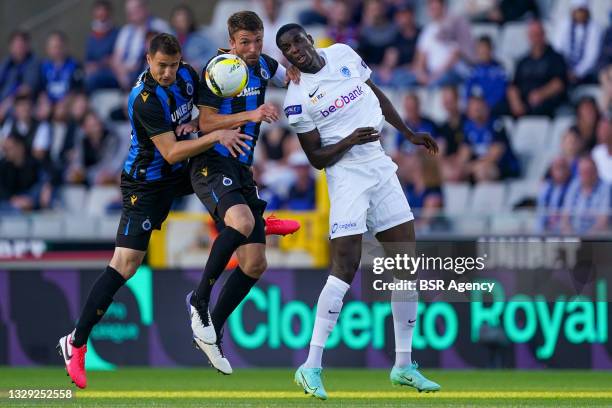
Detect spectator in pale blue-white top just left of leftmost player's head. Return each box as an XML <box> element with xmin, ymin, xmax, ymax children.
<box><xmin>112</xmin><ymin>0</ymin><xmax>172</xmax><ymax>90</ymax></box>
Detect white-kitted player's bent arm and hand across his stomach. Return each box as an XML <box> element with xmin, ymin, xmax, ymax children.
<box><xmin>298</xmin><ymin>127</ymin><xmax>380</xmax><ymax>170</ymax></box>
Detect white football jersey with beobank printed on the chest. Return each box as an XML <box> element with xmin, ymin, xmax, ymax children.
<box><xmin>284</xmin><ymin>44</ymin><xmax>385</xmax><ymax>171</ymax></box>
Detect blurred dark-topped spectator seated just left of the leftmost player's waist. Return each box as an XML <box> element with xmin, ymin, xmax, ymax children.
<box><xmin>67</xmin><ymin>111</ymin><xmax>124</xmax><ymax>185</ymax></box>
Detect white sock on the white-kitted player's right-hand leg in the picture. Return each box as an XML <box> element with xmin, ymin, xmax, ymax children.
<box><xmin>391</xmin><ymin>279</ymin><xmax>419</xmax><ymax>367</ymax></box>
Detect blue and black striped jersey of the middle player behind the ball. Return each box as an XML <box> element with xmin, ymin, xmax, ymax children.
<box><xmin>198</xmin><ymin>49</ymin><xmax>278</xmax><ymax>166</ymax></box>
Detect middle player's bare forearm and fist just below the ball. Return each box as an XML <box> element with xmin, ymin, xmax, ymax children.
<box><xmin>199</xmin><ymin>103</ymin><xmax>278</xmax><ymax>133</ymax></box>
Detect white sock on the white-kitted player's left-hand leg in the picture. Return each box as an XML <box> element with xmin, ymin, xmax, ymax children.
<box><xmin>304</xmin><ymin>275</ymin><xmax>350</xmax><ymax>368</ymax></box>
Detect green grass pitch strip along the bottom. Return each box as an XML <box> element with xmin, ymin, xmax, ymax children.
<box><xmin>0</xmin><ymin>367</ymin><xmax>612</xmax><ymax>408</ymax></box>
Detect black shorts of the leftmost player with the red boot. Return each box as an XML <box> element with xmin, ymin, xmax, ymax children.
<box><xmin>115</xmin><ymin>170</ymin><xmax>193</xmax><ymax>251</ymax></box>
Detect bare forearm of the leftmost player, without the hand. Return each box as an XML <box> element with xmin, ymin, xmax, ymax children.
<box><xmin>151</xmin><ymin>132</ymin><xmax>219</xmax><ymax>164</ymax></box>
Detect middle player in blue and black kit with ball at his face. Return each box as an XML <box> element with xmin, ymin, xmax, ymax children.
<box><xmin>186</xmin><ymin>11</ymin><xmax>297</xmax><ymax>374</ymax></box>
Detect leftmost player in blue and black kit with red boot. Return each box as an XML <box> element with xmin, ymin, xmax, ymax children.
<box><xmin>58</xmin><ymin>34</ymin><xmax>251</xmax><ymax>388</ymax></box>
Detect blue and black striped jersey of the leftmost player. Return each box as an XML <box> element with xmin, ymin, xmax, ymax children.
<box><xmin>123</xmin><ymin>63</ymin><xmax>199</xmax><ymax>181</ymax></box>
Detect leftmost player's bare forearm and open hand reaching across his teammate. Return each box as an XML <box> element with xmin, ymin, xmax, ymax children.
<box><xmin>151</xmin><ymin>130</ymin><xmax>252</xmax><ymax>164</ymax></box>
